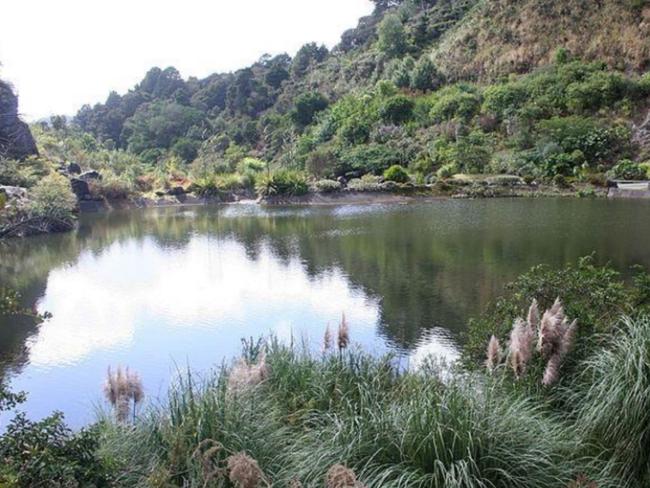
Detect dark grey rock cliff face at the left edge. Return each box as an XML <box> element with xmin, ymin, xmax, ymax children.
<box><xmin>0</xmin><ymin>81</ymin><xmax>38</xmax><ymax>159</ymax></box>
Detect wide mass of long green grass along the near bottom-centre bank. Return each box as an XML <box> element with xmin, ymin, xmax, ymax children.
<box><xmin>95</xmin><ymin>341</ymin><xmax>619</xmax><ymax>488</ymax></box>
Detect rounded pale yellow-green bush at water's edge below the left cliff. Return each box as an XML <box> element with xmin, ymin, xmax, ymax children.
<box><xmin>29</xmin><ymin>173</ymin><xmax>77</xmax><ymax>222</ymax></box>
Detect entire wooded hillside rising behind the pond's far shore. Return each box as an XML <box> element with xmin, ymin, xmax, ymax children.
<box><xmin>3</xmin><ymin>0</ymin><xmax>650</xmax><ymax>206</ymax></box>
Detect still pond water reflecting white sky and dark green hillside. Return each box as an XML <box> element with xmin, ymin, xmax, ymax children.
<box><xmin>0</xmin><ymin>199</ymin><xmax>650</xmax><ymax>428</ymax></box>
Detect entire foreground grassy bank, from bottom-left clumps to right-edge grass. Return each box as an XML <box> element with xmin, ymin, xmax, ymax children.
<box><xmin>93</xmin><ymin>318</ymin><xmax>650</xmax><ymax>487</ymax></box>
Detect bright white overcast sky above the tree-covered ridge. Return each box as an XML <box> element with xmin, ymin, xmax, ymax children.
<box><xmin>0</xmin><ymin>0</ymin><xmax>372</xmax><ymax>120</ymax></box>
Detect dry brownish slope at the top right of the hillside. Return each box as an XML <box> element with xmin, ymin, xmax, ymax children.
<box><xmin>433</xmin><ymin>0</ymin><xmax>650</xmax><ymax>79</ymax></box>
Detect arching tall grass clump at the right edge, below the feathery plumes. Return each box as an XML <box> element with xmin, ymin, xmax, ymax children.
<box><xmin>568</xmin><ymin>316</ymin><xmax>650</xmax><ymax>486</ymax></box>
